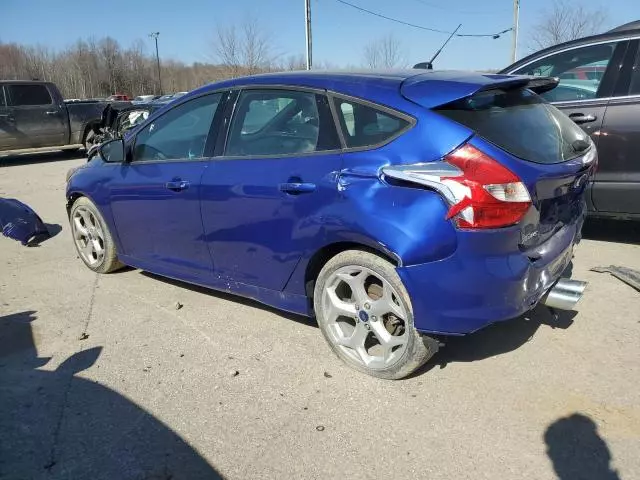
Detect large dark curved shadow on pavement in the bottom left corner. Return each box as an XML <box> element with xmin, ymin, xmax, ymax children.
<box><xmin>0</xmin><ymin>311</ymin><xmax>222</xmax><ymax>480</ymax></box>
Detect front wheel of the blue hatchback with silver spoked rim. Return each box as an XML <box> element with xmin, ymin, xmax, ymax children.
<box><xmin>69</xmin><ymin>197</ymin><xmax>123</xmax><ymax>273</ymax></box>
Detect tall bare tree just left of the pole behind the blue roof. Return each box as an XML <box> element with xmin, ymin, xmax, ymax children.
<box><xmin>213</xmin><ymin>18</ymin><xmax>277</xmax><ymax>77</ymax></box>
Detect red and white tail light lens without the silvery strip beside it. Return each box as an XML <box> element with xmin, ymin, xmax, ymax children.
<box><xmin>441</xmin><ymin>144</ymin><xmax>531</xmax><ymax>228</ymax></box>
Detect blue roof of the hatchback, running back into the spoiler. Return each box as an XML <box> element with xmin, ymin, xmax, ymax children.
<box><xmin>182</xmin><ymin>69</ymin><xmax>536</xmax><ymax>107</ymax></box>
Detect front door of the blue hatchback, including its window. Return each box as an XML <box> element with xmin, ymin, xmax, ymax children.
<box><xmin>107</xmin><ymin>92</ymin><xmax>228</xmax><ymax>280</ymax></box>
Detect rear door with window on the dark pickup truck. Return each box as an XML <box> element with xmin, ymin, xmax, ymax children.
<box><xmin>6</xmin><ymin>83</ymin><xmax>68</xmax><ymax>148</ymax></box>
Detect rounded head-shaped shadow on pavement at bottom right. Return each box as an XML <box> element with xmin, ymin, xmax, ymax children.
<box><xmin>544</xmin><ymin>413</ymin><xmax>620</xmax><ymax>480</ymax></box>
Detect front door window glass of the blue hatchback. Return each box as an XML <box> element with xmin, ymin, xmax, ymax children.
<box><xmin>133</xmin><ymin>93</ymin><xmax>222</xmax><ymax>162</ymax></box>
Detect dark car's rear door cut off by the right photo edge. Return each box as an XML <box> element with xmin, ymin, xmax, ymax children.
<box><xmin>592</xmin><ymin>39</ymin><xmax>640</xmax><ymax>215</ymax></box>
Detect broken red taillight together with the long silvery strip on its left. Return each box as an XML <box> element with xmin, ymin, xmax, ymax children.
<box><xmin>383</xmin><ymin>144</ymin><xmax>531</xmax><ymax>229</ymax></box>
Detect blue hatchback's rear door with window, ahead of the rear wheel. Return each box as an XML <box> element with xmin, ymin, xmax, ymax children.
<box><xmin>202</xmin><ymin>88</ymin><xmax>341</xmax><ymax>290</ymax></box>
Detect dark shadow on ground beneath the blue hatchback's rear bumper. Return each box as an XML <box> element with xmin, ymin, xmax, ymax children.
<box><xmin>411</xmin><ymin>305</ymin><xmax>578</xmax><ymax>376</ymax></box>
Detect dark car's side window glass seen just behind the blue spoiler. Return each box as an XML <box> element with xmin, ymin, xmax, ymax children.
<box><xmin>511</xmin><ymin>42</ymin><xmax>617</xmax><ymax>102</ymax></box>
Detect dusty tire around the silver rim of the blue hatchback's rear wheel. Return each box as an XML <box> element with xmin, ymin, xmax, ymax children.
<box><xmin>314</xmin><ymin>250</ymin><xmax>439</xmax><ymax>380</ymax></box>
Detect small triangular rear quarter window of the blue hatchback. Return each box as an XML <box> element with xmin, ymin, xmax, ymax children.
<box><xmin>334</xmin><ymin>98</ymin><xmax>410</xmax><ymax>148</ymax></box>
